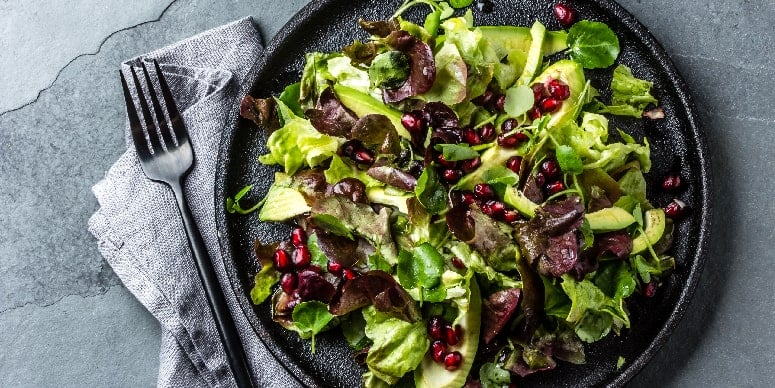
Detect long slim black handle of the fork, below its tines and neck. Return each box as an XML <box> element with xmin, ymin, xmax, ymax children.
<box><xmin>170</xmin><ymin>181</ymin><xmax>253</xmax><ymax>388</ymax></box>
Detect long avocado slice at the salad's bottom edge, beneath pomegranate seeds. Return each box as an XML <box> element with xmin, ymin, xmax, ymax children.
<box><xmin>414</xmin><ymin>277</ymin><xmax>482</xmax><ymax>388</ymax></box>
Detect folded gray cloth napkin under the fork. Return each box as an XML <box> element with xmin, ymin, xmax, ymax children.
<box><xmin>89</xmin><ymin>18</ymin><xmax>297</xmax><ymax>387</ymax></box>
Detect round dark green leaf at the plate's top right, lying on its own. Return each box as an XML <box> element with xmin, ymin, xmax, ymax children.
<box><xmin>568</xmin><ymin>20</ymin><xmax>619</xmax><ymax>69</ymax></box>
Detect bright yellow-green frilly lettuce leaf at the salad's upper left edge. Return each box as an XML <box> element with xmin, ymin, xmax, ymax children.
<box><xmin>258</xmin><ymin>100</ymin><xmax>344</xmax><ymax>175</ymax></box>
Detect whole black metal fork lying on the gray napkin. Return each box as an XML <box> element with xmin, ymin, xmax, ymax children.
<box><xmin>119</xmin><ymin>60</ymin><xmax>253</xmax><ymax>387</ymax></box>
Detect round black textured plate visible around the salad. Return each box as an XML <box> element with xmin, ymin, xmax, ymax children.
<box><xmin>215</xmin><ymin>0</ymin><xmax>710</xmax><ymax>387</ymax></box>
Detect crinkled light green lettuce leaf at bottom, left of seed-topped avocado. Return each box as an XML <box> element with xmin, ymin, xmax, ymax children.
<box><xmin>362</xmin><ymin>306</ymin><xmax>430</xmax><ymax>385</ymax></box>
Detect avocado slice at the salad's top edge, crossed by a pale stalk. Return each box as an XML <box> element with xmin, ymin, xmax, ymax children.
<box><xmin>479</xmin><ymin>26</ymin><xmax>568</xmax><ymax>58</ymax></box>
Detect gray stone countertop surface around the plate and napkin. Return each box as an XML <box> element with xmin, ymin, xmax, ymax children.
<box><xmin>0</xmin><ymin>0</ymin><xmax>775</xmax><ymax>387</ymax></box>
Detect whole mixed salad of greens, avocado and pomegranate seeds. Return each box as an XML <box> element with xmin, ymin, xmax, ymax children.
<box><xmin>226</xmin><ymin>0</ymin><xmax>686</xmax><ymax>387</ymax></box>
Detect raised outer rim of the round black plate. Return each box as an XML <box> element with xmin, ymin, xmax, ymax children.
<box><xmin>214</xmin><ymin>0</ymin><xmax>713</xmax><ymax>387</ymax></box>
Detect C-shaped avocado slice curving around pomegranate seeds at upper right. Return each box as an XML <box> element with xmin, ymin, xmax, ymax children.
<box><xmin>531</xmin><ymin>59</ymin><xmax>586</xmax><ymax>128</ymax></box>
